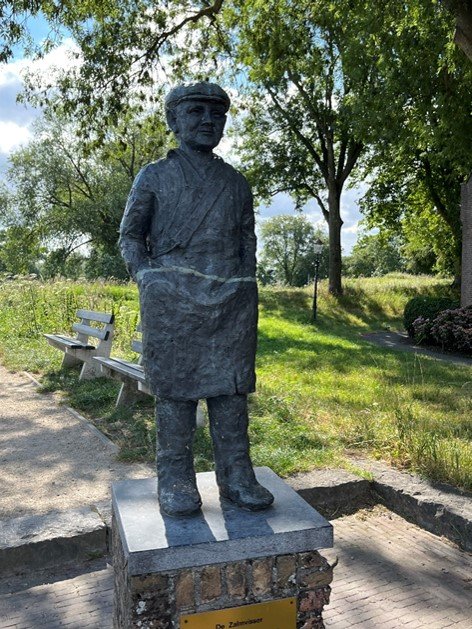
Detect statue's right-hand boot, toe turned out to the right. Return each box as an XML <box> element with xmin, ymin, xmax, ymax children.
<box><xmin>207</xmin><ymin>395</ymin><xmax>274</xmax><ymax>511</ymax></box>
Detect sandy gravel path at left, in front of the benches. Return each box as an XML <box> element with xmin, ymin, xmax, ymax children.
<box><xmin>0</xmin><ymin>366</ymin><xmax>153</xmax><ymax>520</ymax></box>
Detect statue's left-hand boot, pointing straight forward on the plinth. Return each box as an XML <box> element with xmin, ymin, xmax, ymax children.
<box><xmin>156</xmin><ymin>398</ymin><xmax>202</xmax><ymax>517</ymax></box>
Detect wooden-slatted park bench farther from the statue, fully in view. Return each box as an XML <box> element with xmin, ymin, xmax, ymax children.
<box><xmin>44</xmin><ymin>310</ymin><xmax>114</xmax><ymax>380</ymax></box>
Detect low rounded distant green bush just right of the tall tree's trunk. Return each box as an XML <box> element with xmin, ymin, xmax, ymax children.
<box><xmin>344</xmin><ymin>234</ymin><xmax>406</xmax><ymax>277</ymax></box>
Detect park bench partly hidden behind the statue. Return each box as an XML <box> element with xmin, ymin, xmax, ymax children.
<box><xmin>94</xmin><ymin>325</ymin><xmax>205</xmax><ymax>426</ymax></box>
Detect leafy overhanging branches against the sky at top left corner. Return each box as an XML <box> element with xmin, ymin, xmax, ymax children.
<box><xmin>0</xmin><ymin>0</ymin><xmax>223</xmax><ymax>141</ymax></box>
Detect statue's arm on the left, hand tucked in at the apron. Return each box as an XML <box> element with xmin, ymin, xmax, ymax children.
<box><xmin>119</xmin><ymin>166</ymin><xmax>154</xmax><ymax>279</ymax></box>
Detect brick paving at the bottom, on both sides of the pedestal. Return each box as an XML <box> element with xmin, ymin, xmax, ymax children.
<box><xmin>0</xmin><ymin>508</ymin><xmax>472</xmax><ymax>629</ymax></box>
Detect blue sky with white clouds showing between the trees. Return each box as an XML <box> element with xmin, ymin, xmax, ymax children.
<box><xmin>0</xmin><ymin>18</ymin><xmax>365</xmax><ymax>254</ymax></box>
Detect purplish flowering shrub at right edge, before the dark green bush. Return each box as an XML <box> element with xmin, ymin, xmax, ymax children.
<box><xmin>430</xmin><ymin>306</ymin><xmax>472</xmax><ymax>353</ymax></box>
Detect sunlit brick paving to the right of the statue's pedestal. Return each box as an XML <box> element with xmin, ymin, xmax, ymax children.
<box><xmin>324</xmin><ymin>509</ymin><xmax>472</xmax><ymax>629</ymax></box>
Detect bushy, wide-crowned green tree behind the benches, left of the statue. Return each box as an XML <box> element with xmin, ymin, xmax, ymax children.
<box><xmin>0</xmin><ymin>105</ymin><xmax>168</xmax><ymax>278</ymax></box>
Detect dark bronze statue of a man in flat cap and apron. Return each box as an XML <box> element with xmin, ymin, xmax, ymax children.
<box><xmin>120</xmin><ymin>82</ymin><xmax>273</xmax><ymax>516</ymax></box>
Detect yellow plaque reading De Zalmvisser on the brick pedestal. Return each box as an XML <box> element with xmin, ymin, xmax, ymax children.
<box><xmin>180</xmin><ymin>598</ymin><xmax>297</xmax><ymax>629</ymax></box>
